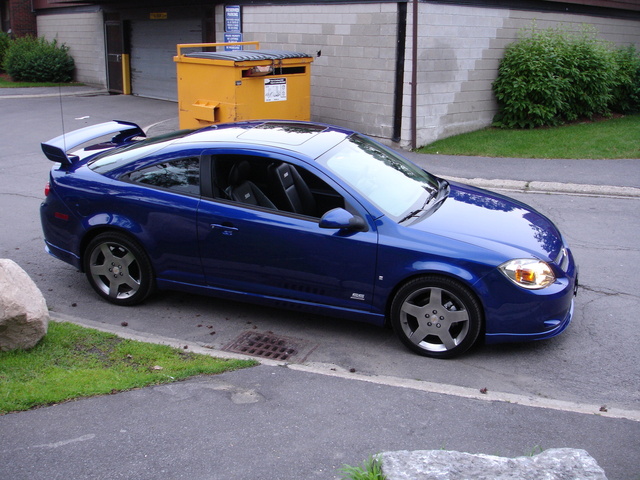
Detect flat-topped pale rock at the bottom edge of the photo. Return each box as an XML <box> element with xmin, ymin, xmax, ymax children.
<box><xmin>378</xmin><ymin>448</ymin><xmax>607</xmax><ymax>480</ymax></box>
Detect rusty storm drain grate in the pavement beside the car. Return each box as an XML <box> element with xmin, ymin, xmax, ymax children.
<box><xmin>224</xmin><ymin>332</ymin><xmax>307</xmax><ymax>360</ymax></box>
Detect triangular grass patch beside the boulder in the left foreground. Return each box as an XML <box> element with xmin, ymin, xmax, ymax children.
<box><xmin>0</xmin><ymin>322</ymin><xmax>257</xmax><ymax>415</ymax></box>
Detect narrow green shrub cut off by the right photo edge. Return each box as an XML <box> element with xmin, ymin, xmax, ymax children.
<box><xmin>611</xmin><ymin>45</ymin><xmax>640</xmax><ymax>113</ymax></box>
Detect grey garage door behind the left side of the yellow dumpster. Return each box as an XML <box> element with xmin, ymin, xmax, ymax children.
<box><xmin>131</xmin><ymin>18</ymin><xmax>202</xmax><ymax>101</ymax></box>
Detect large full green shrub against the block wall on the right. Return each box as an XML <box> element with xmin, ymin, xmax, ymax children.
<box><xmin>493</xmin><ymin>25</ymin><xmax>617</xmax><ymax>128</ymax></box>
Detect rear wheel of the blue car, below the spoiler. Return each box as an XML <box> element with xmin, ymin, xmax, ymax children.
<box><xmin>84</xmin><ymin>232</ymin><xmax>154</xmax><ymax>305</ymax></box>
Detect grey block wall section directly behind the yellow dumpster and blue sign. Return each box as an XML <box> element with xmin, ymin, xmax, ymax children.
<box><xmin>221</xmin><ymin>3</ymin><xmax>397</xmax><ymax>138</ymax></box>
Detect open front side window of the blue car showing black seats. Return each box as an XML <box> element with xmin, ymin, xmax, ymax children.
<box><xmin>213</xmin><ymin>155</ymin><xmax>345</xmax><ymax>218</ymax></box>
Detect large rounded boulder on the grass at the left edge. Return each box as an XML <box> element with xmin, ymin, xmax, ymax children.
<box><xmin>0</xmin><ymin>259</ymin><xmax>49</xmax><ymax>352</ymax></box>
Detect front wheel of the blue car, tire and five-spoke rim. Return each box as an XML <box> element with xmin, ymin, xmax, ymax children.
<box><xmin>391</xmin><ymin>275</ymin><xmax>482</xmax><ymax>358</ymax></box>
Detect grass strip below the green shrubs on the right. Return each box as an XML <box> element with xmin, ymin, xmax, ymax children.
<box><xmin>418</xmin><ymin>115</ymin><xmax>640</xmax><ymax>159</ymax></box>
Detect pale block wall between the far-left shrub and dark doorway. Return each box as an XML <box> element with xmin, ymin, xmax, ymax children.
<box><xmin>37</xmin><ymin>9</ymin><xmax>107</xmax><ymax>87</ymax></box>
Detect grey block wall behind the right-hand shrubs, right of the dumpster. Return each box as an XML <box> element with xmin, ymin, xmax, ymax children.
<box><xmin>410</xmin><ymin>3</ymin><xmax>640</xmax><ymax>146</ymax></box>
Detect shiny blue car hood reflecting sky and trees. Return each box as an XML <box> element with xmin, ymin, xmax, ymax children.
<box><xmin>409</xmin><ymin>182</ymin><xmax>563</xmax><ymax>261</ymax></box>
